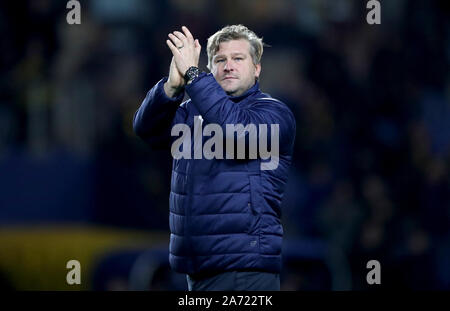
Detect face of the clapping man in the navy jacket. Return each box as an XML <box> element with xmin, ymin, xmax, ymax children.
<box><xmin>211</xmin><ymin>39</ymin><xmax>261</xmax><ymax>96</ymax></box>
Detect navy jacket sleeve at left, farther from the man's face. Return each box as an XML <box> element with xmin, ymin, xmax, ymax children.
<box><xmin>133</xmin><ymin>77</ymin><xmax>186</xmax><ymax>149</ymax></box>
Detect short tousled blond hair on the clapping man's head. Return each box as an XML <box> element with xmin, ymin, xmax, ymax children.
<box><xmin>206</xmin><ymin>24</ymin><xmax>264</xmax><ymax>70</ymax></box>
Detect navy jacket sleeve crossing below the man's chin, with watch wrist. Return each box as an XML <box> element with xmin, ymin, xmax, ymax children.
<box><xmin>186</xmin><ymin>73</ymin><xmax>296</xmax><ymax>154</ymax></box>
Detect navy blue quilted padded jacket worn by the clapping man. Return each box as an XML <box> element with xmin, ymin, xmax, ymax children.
<box><xmin>133</xmin><ymin>73</ymin><xmax>295</xmax><ymax>275</ymax></box>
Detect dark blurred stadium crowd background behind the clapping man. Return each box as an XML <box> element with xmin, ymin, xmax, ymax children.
<box><xmin>0</xmin><ymin>0</ymin><xmax>450</xmax><ymax>290</ymax></box>
